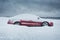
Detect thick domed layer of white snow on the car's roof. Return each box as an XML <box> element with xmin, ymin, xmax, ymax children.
<box><xmin>12</xmin><ymin>14</ymin><xmax>39</xmax><ymax>20</ymax></box>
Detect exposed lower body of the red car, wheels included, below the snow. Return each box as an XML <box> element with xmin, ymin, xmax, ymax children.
<box><xmin>8</xmin><ymin>20</ymin><xmax>53</xmax><ymax>27</ymax></box>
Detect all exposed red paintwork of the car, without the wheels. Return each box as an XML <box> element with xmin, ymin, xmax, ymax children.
<box><xmin>8</xmin><ymin>20</ymin><xmax>53</xmax><ymax>26</ymax></box>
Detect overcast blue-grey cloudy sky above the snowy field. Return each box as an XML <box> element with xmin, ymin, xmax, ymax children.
<box><xmin>0</xmin><ymin>0</ymin><xmax>60</xmax><ymax>17</ymax></box>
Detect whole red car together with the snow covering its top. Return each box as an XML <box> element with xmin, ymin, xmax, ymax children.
<box><xmin>8</xmin><ymin>14</ymin><xmax>53</xmax><ymax>27</ymax></box>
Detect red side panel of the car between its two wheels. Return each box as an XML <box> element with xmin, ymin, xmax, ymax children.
<box><xmin>20</xmin><ymin>20</ymin><xmax>42</xmax><ymax>26</ymax></box>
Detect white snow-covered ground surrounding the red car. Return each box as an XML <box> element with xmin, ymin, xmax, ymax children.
<box><xmin>0</xmin><ymin>16</ymin><xmax>60</xmax><ymax>40</ymax></box>
